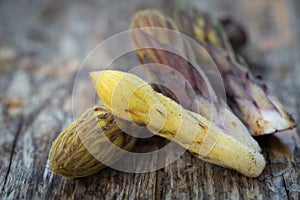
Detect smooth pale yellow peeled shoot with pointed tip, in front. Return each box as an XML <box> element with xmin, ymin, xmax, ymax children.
<box><xmin>90</xmin><ymin>70</ymin><xmax>265</xmax><ymax>177</ymax></box>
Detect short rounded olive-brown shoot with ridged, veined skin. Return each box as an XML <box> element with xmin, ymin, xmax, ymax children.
<box><xmin>49</xmin><ymin>106</ymin><xmax>136</xmax><ymax>178</ymax></box>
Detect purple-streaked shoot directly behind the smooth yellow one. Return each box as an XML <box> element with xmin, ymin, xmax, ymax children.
<box><xmin>131</xmin><ymin>10</ymin><xmax>260</xmax><ymax>151</ymax></box>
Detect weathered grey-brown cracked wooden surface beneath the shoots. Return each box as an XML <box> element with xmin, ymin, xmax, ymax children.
<box><xmin>0</xmin><ymin>0</ymin><xmax>300</xmax><ymax>199</ymax></box>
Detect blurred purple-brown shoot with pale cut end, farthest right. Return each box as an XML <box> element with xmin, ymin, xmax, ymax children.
<box><xmin>173</xmin><ymin>8</ymin><xmax>296</xmax><ymax>136</ymax></box>
